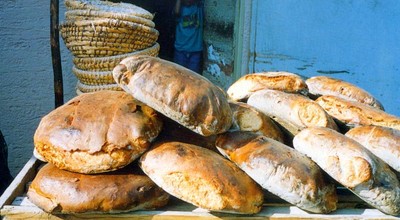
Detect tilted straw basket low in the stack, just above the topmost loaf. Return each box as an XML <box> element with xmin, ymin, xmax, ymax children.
<box><xmin>73</xmin><ymin>43</ymin><xmax>160</xmax><ymax>70</ymax></box>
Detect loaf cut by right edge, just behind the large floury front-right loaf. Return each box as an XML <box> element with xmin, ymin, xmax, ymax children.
<box><xmin>346</xmin><ymin>125</ymin><xmax>400</xmax><ymax>172</ymax></box>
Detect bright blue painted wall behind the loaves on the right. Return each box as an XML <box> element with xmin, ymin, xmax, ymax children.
<box><xmin>249</xmin><ymin>0</ymin><xmax>400</xmax><ymax>116</ymax></box>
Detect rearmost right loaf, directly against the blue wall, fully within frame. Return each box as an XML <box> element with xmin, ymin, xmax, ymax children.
<box><xmin>306</xmin><ymin>76</ymin><xmax>384</xmax><ymax>110</ymax></box>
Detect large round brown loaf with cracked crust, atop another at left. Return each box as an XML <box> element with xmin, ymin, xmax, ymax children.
<box><xmin>34</xmin><ymin>90</ymin><xmax>162</xmax><ymax>173</ymax></box>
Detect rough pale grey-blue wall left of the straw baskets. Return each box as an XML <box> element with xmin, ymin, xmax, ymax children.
<box><xmin>0</xmin><ymin>0</ymin><xmax>76</xmax><ymax>176</ymax></box>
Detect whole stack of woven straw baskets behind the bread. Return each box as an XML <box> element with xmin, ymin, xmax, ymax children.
<box><xmin>60</xmin><ymin>0</ymin><xmax>160</xmax><ymax>94</ymax></box>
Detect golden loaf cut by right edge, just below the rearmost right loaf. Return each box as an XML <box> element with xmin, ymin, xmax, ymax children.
<box><xmin>315</xmin><ymin>95</ymin><xmax>400</xmax><ymax>130</ymax></box>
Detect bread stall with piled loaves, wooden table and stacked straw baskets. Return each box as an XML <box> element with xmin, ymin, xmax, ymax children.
<box><xmin>0</xmin><ymin>0</ymin><xmax>400</xmax><ymax>219</ymax></box>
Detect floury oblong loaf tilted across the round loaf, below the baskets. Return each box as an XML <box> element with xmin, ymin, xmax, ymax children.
<box><xmin>113</xmin><ymin>55</ymin><xmax>232</xmax><ymax>136</ymax></box>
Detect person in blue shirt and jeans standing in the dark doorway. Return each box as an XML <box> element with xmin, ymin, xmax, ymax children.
<box><xmin>174</xmin><ymin>0</ymin><xmax>204</xmax><ymax>74</ymax></box>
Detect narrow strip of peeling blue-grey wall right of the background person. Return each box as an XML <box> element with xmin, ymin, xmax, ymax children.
<box><xmin>203</xmin><ymin>0</ymin><xmax>237</xmax><ymax>89</ymax></box>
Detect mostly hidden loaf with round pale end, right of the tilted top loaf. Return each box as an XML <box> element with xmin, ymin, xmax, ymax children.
<box><xmin>229</xmin><ymin>101</ymin><xmax>284</xmax><ymax>142</ymax></box>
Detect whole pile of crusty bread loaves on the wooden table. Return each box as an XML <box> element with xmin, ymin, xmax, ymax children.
<box><xmin>28</xmin><ymin>55</ymin><xmax>400</xmax><ymax>215</ymax></box>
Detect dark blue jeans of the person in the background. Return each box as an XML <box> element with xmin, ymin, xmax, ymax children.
<box><xmin>174</xmin><ymin>50</ymin><xmax>202</xmax><ymax>74</ymax></box>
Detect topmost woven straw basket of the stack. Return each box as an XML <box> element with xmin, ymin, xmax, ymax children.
<box><xmin>65</xmin><ymin>0</ymin><xmax>154</xmax><ymax>20</ymax></box>
